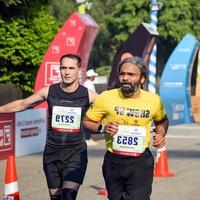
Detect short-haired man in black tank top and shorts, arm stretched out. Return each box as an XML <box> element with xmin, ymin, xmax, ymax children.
<box><xmin>0</xmin><ymin>54</ymin><xmax>97</xmax><ymax>200</ymax></box>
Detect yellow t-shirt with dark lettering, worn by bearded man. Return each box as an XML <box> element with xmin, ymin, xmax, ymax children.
<box><xmin>86</xmin><ymin>89</ymin><xmax>166</xmax><ymax>152</ymax></box>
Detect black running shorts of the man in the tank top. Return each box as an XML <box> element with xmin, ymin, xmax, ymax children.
<box><xmin>43</xmin><ymin>143</ymin><xmax>88</xmax><ymax>189</ymax></box>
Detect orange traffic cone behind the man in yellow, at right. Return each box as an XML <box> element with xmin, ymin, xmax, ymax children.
<box><xmin>154</xmin><ymin>146</ymin><xmax>174</xmax><ymax>177</ymax></box>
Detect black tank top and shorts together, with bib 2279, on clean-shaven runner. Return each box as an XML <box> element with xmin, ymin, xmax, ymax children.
<box><xmin>43</xmin><ymin>83</ymin><xmax>89</xmax><ymax>199</ymax></box>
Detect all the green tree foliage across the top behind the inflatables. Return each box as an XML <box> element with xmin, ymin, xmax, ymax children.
<box><xmin>0</xmin><ymin>0</ymin><xmax>200</xmax><ymax>91</ymax></box>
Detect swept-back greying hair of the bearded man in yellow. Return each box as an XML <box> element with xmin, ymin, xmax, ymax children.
<box><xmin>118</xmin><ymin>56</ymin><xmax>148</xmax><ymax>79</ymax></box>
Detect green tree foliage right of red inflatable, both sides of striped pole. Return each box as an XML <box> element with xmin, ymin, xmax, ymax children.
<box><xmin>91</xmin><ymin>0</ymin><xmax>200</xmax><ymax>76</ymax></box>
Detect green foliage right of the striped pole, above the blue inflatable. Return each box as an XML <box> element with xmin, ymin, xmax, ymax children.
<box><xmin>158</xmin><ymin>0</ymin><xmax>200</xmax><ymax>69</ymax></box>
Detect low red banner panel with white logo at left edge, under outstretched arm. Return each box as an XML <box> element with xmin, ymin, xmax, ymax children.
<box><xmin>0</xmin><ymin>114</ymin><xmax>15</xmax><ymax>160</ymax></box>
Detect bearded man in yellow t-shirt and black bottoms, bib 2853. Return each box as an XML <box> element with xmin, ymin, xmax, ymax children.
<box><xmin>83</xmin><ymin>57</ymin><xmax>168</xmax><ymax>200</ymax></box>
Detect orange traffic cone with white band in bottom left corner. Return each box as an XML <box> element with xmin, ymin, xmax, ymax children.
<box><xmin>3</xmin><ymin>156</ymin><xmax>20</xmax><ymax>200</ymax></box>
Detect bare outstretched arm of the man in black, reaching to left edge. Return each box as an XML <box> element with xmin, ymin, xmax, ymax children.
<box><xmin>0</xmin><ymin>87</ymin><xmax>49</xmax><ymax>113</ymax></box>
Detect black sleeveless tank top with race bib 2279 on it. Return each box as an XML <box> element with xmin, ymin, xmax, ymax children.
<box><xmin>47</xmin><ymin>83</ymin><xmax>89</xmax><ymax>147</ymax></box>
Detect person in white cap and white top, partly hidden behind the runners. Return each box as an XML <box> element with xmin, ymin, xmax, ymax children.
<box><xmin>83</xmin><ymin>69</ymin><xmax>98</xmax><ymax>146</ymax></box>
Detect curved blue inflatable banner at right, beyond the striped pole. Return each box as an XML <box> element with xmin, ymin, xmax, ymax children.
<box><xmin>160</xmin><ymin>34</ymin><xmax>199</xmax><ymax>125</ymax></box>
